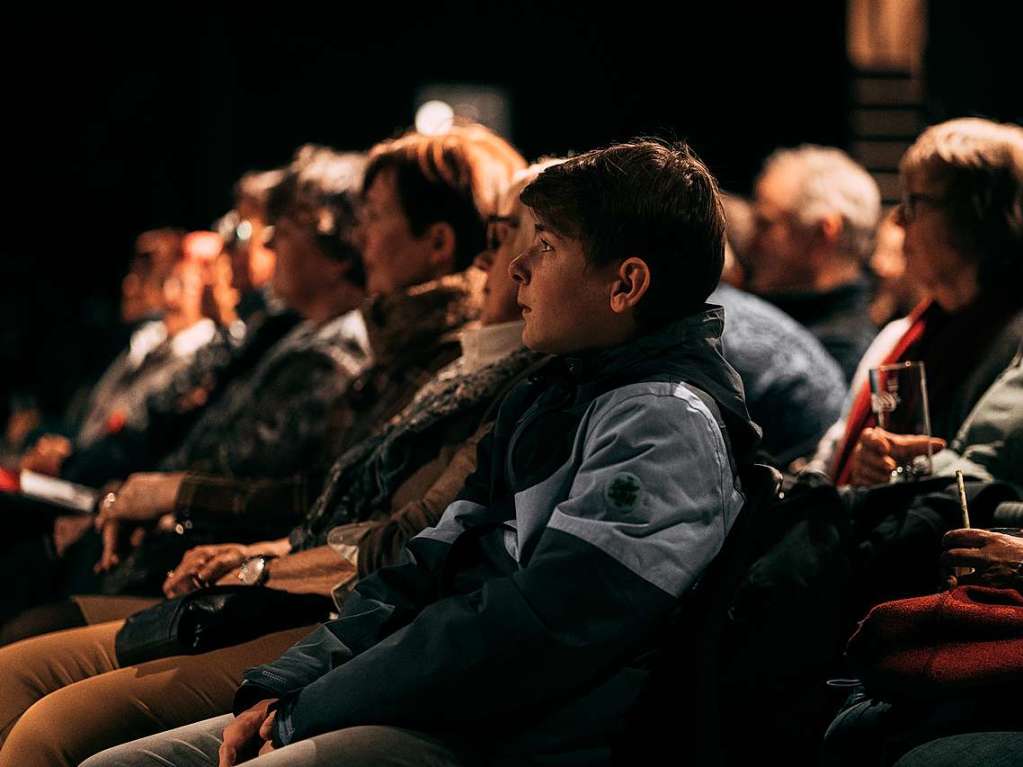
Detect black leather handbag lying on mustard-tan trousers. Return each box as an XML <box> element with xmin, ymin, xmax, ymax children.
<box><xmin>115</xmin><ymin>585</ymin><xmax>333</xmax><ymax>668</ymax></box>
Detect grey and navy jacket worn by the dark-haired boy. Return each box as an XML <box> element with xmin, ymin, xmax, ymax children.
<box><xmin>235</xmin><ymin>307</ymin><xmax>759</xmax><ymax>764</ymax></box>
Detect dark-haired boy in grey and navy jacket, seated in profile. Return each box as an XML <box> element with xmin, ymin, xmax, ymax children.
<box><xmin>86</xmin><ymin>141</ymin><xmax>758</xmax><ymax>767</ymax></box>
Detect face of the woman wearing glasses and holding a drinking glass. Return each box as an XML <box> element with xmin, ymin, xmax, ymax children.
<box><xmin>898</xmin><ymin>176</ymin><xmax>978</xmax><ymax>312</ymax></box>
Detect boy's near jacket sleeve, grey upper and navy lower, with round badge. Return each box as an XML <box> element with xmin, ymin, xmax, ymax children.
<box><xmin>259</xmin><ymin>395</ymin><xmax>742</xmax><ymax>745</ymax></box>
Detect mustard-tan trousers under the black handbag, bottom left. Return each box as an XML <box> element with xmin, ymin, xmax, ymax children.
<box><xmin>0</xmin><ymin>621</ymin><xmax>314</xmax><ymax>767</ymax></box>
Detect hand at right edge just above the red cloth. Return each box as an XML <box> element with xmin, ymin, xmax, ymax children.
<box><xmin>941</xmin><ymin>529</ymin><xmax>1023</xmax><ymax>588</ymax></box>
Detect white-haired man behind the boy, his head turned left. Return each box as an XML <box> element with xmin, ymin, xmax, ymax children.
<box><xmin>744</xmin><ymin>144</ymin><xmax>881</xmax><ymax>379</ymax></box>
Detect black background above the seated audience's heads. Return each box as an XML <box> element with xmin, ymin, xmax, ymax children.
<box><xmin>0</xmin><ymin>0</ymin><xmax>1023</xmax><ymax>415</ymax></box>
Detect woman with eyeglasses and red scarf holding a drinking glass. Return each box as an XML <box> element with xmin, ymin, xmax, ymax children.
<box><xmin>810</xmin><ymin>118</ymin><xmax>1023</xmax><ymax>485</ymax></box>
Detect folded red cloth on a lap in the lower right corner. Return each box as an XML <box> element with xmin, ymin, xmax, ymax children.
<box><xmin>846</xmin><ymin>586</ymin><xmax>1023</xmax><ymax>700</ymax></box>
